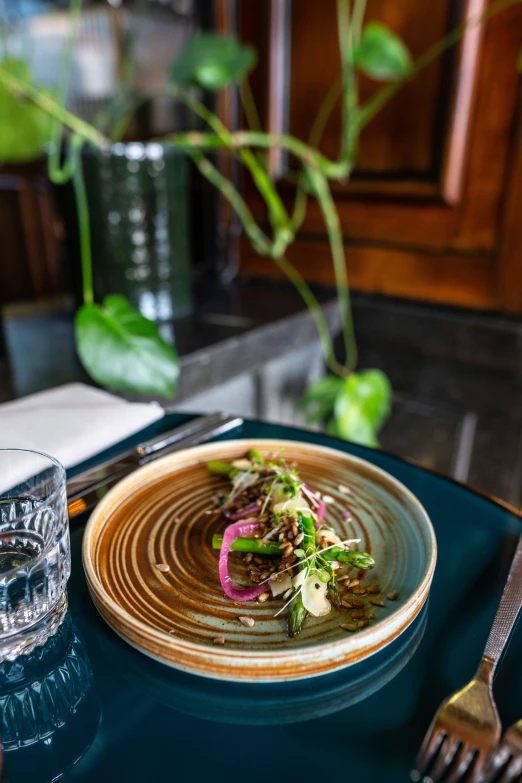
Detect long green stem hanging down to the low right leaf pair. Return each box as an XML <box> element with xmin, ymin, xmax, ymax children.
<box><xmin>309</xmin><ymin>167</ymin><xmax>357</xmax><ymax>372</ymax></box>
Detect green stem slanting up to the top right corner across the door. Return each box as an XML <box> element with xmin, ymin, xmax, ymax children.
<box><xmin>358</xmin><ymin>0</ymin><xmax>522</xmax><ymax>131</ymax></box>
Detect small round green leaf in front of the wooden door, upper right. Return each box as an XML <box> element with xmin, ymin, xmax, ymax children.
<box><xmin>353</xmin><ymin>22</ymin><xmax>412</xmax><ymax>82</ymax></box>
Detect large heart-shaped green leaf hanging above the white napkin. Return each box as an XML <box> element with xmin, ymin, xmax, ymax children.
<box><xmin>76</xmin><ymin>296</ymin><xmax>179</xmax><ymax>397</ymax></box>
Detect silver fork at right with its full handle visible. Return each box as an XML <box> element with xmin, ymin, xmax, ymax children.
<box><xmin>412</xmin><ymin>537</ymin><xmax>522</xmax><ymax>783</ymax></box>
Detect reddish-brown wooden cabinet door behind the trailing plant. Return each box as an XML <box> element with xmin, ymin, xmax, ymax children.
<box><xmin>237</xmin><ymin>0</ymin><xmax>522</xmax><ymax>312</ymax></box>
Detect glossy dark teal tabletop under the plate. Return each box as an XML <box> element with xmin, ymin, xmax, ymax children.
<box><xmin>4</xmin><ymin>415</ymin><xmax>522</xmax><ymax>783</ymax></box>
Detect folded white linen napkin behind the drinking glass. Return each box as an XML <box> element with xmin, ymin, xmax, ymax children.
<box><xmin>0</xmin><ymin>383</ymin><xmax>165</xmax><ymax>468</ymax></box>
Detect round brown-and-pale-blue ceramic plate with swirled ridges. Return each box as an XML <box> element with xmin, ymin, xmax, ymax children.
<box><xmin>83</xmin><ymin>440</ymin><xmax>436</xmax><ymax>682</ymax></box>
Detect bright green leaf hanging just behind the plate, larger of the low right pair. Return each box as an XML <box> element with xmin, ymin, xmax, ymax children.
<box><xmin>334</xmin><ymin>370</ymin><xmax>392</xmax><ymax>446</ymax></box>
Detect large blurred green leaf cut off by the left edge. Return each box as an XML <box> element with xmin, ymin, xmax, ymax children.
<box><xmin>0</xmin><ymin>58</ymin><xmax>51</xmax><ymax>163</ymax></box>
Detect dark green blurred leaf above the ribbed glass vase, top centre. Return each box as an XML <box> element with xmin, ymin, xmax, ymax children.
<box><xmin>170</xmin><ymin>33</ymin><xmax>256</xmax><ymax>90</ymax></box>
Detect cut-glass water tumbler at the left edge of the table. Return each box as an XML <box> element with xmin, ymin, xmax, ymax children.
<box><xmin>0</xmin><ymin>449</ymin><xmax>71</xmax><ymax>662</ymax></box>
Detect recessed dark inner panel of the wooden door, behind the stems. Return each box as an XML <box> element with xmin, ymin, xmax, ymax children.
<box><xmin>289</xmin><ymin>0</ymin><xmax>453</xmax><ymax>177</ymax></box>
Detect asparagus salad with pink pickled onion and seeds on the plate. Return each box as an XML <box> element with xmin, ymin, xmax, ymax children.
<box><xmin>208</xmin><ymin>451</ymin><xmax>397</xmax><ymax>641</ymax></box>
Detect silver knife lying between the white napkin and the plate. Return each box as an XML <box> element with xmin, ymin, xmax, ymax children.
<box><xmin>67</xmin><ymin>413</ymin><xmax>243</xmax><ymax>517</ymax></box>
